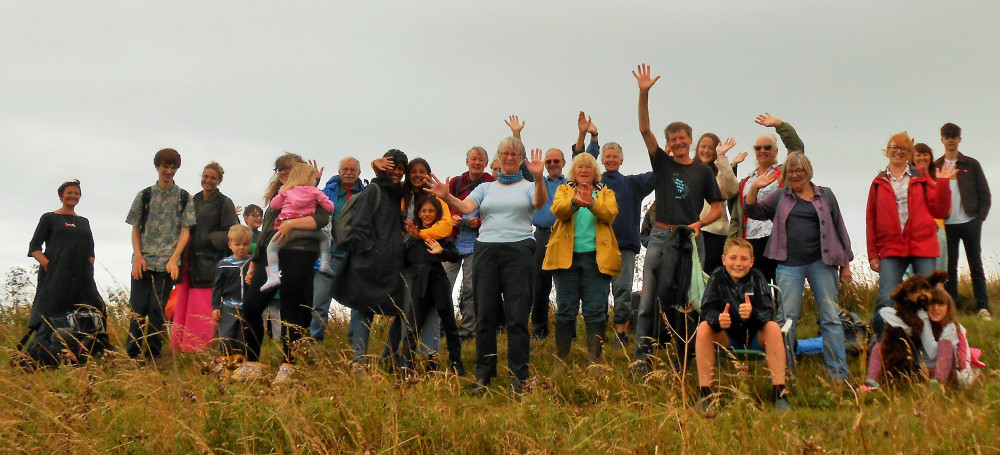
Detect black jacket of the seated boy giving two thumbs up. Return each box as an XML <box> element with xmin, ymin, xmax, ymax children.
<box><xmin>701</xmin><ymin>267</ymin><xmax>774</xmax><ymax>332</ymax></box>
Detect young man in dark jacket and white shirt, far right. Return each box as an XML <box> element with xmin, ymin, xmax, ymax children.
<box><xmin>934</xmin><ymin>123</ymin><xmax>993</xmax><ymax>321</ymax></box>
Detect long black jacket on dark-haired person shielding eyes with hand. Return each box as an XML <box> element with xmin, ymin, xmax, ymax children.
<box><xmin>330</xmin><ymin>176</ymin><xmax>405</xmax><ymax>315</ymax></box>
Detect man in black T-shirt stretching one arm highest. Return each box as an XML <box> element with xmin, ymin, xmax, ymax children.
<box><xmin>632</xmin><ymin>64</ymin><xmax>722</xmax><ymax>373</ymax></box>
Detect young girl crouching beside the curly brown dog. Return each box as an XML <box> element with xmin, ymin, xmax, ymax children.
<box><xmin>923</xmin><ymin>288</ymin><xmax>978</xmax><ymax>385</ymax></box>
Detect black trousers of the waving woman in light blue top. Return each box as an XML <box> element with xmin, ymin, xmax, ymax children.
<box><xmin>472</xmin><ymin>239</ymin><xmax>535</xmax><ymax>383</ymax></box>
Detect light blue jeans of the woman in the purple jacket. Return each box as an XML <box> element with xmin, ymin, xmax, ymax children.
<box><xmin>774</xmin><ymin>259</ymin><xmax>844</xmax><ymax>381</ymax></box>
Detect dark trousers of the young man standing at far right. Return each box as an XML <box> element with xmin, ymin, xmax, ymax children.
<box><xmin>944</xmin><ymin>219</ymin><xmax>990</xmax><ymax>310</ymax></box>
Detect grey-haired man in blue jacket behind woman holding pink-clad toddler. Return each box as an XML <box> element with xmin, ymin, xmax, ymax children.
<box><xmin>309</xmin><ymin>156</ymin><xmax>366</xmax><ymax>343</ymax></box>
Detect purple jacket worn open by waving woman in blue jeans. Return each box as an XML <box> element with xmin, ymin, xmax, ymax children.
<box><xmin>744</xmin><ymin>183</ymin><xmax>854</xmax><ymax>267</ymax></box>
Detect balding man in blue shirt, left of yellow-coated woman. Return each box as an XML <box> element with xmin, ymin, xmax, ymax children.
<box><xmin>531</xmin><ymin>148</ymin><xmax>566</xmax><ymax>340</ymax></box>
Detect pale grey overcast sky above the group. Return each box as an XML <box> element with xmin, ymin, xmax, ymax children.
<box><xmin>0</xmin><ymin>0</ymin><xmax>1000</xmax><ymax>292</ymax></box>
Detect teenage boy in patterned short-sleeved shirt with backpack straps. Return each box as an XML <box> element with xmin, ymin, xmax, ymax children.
<box><xmin>125</xmin><ymin>148</ymin><xmax>195</xmax><ymax>358</ymax></box>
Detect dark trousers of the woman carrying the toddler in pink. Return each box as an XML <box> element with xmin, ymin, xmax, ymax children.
<box><xmin>243</xmin><ymin>249</ymin><xmax>319</xmax><ymax>363</ymax></box>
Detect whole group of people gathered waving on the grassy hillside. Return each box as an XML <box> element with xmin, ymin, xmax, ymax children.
<box><xmin>29</xmin><ymin>65</ymin><xmax>990</xmax><ymax>409</ymax></box>
